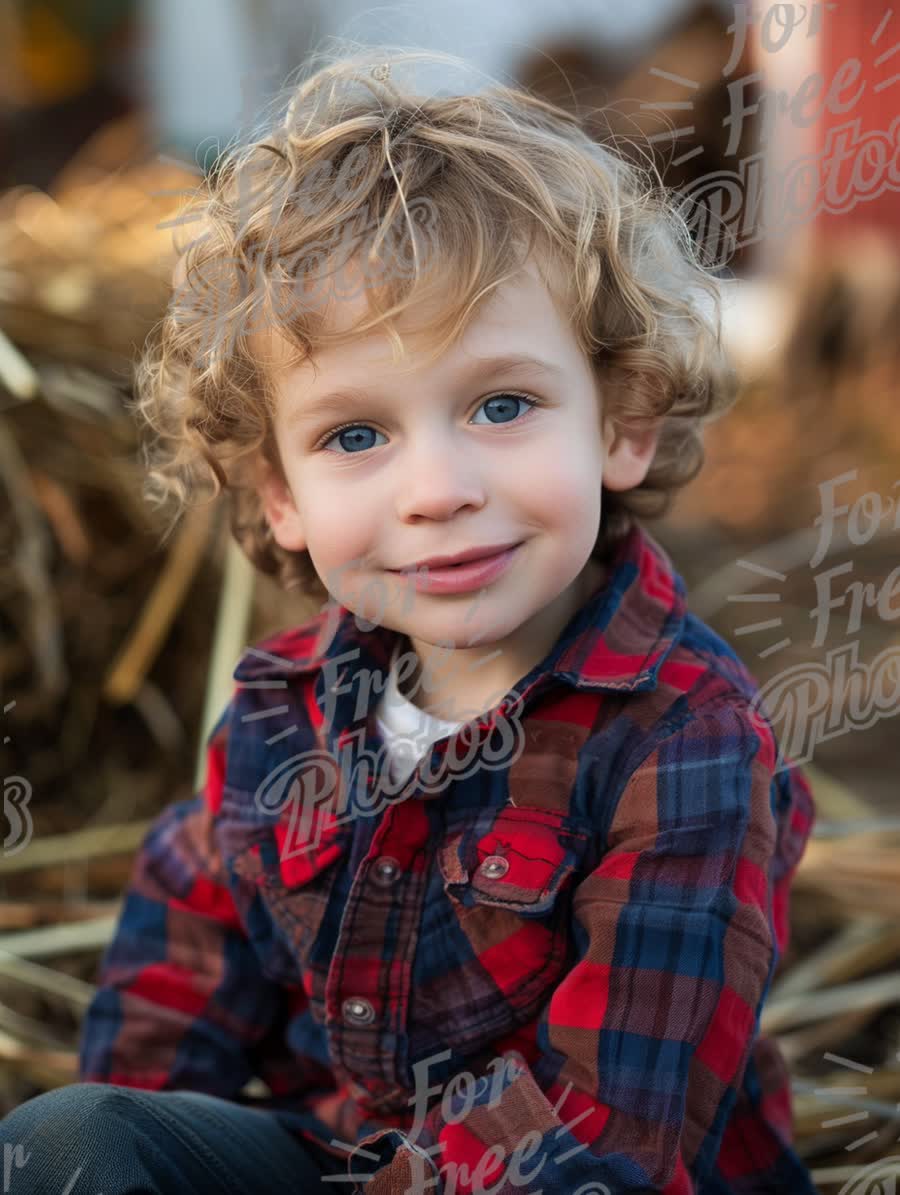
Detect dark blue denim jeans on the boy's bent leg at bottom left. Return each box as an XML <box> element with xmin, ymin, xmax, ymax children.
<box><xmin>0</xmin><ymin>1083</ymin><xmax>351</xmax><ymax>1195</ymax></box>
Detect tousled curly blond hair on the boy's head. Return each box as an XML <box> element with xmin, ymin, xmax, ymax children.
<box><xmin>134</xmin><ymin>45</ymin><xmax>735</xmax><ymax>596</ymax></box>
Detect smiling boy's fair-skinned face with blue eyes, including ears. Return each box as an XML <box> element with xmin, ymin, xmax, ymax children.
<box><xmin>259</xmin><ymin>253</ymin><xmax>655</xmax><ymax>658</ymax></box>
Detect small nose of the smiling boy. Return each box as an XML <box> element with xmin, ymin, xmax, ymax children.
<box><xmin>397</xmin><ymin>429</ymin><xmax>486</xmax><ymax>522</ymax></box>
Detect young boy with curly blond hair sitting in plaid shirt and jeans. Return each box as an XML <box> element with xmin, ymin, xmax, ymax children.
<box><xmin>4</xmin><ymin>51</ymin><xmax>814</xmax><ymax>1195</ymax></box>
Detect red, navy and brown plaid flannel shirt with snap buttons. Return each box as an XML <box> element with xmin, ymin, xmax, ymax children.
<box><xmin>80</xmin><ymin>525</ymin><xmax>815</xmax><ymax>1195</ymax></box>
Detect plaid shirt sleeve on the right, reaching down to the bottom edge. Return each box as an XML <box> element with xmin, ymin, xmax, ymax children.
<box><xmin>351</xmin><ymin>703</ymin><xmax>807</xmax><ymax>1195</ymax></box>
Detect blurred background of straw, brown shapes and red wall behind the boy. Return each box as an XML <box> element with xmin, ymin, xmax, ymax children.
<box><xmin>0</xmin><ymin>0</ymin><xmax>900</xmax><ymax>1193</ymax></box>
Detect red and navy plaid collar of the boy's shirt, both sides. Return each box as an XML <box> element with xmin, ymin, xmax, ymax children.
<box><xmin>233</xmin><ymin>522</ymin><xmax>686</xmax><ymax>692</ymax></box>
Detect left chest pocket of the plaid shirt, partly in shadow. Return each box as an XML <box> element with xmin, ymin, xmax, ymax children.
<box><xmin>233</xmin><ymin>809</ymin><xmax>353</xmax><ymax>984</ymax></box>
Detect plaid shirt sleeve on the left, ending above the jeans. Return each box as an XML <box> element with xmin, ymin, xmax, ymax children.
<box><xmin>79</xmin><ymin>705</ymin><xmax>287</xmax><ymax>1098</ymax></box>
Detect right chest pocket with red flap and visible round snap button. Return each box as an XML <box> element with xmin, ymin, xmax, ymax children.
<box><xmin>420</xmin><ymin>807</ymin><xmax>589</xmax><ymax>1050</ymax></box>
